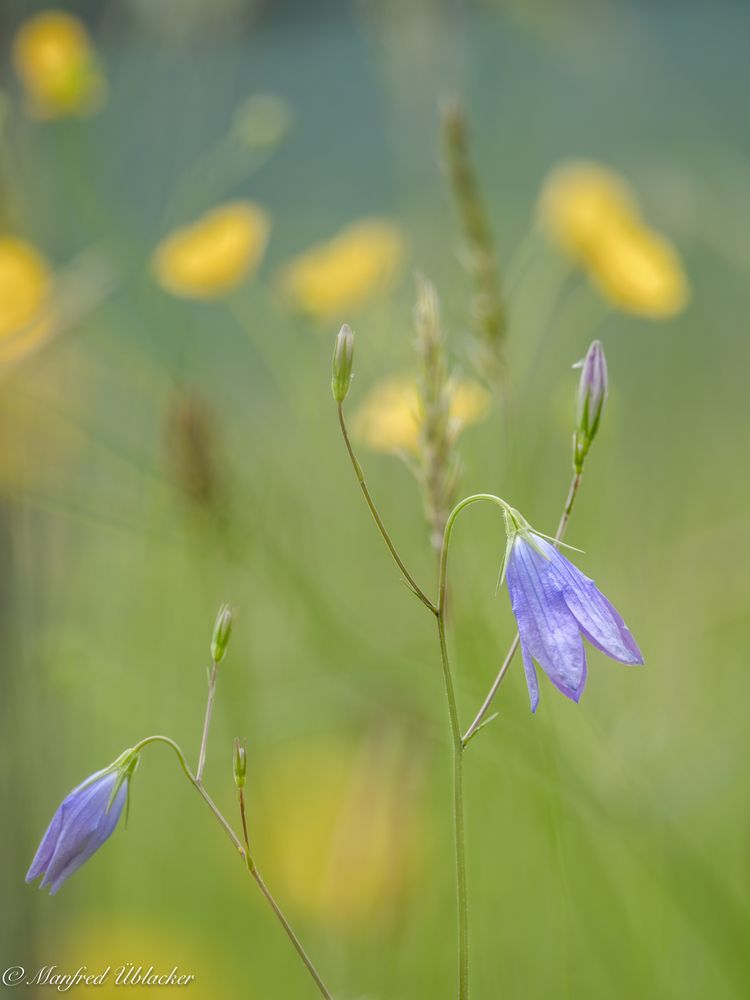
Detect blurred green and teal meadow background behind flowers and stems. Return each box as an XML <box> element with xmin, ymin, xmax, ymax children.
<box><xmin>0</xmin><ymin>0</ymin><xmax>750</xmax><ymax>1000</ymax></box>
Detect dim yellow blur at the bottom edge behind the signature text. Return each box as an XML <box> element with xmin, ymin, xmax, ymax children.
<box><xmin>57</xmin><ymin>917</ymin><xmax>225</xmax><ymax>1000</ymax></box>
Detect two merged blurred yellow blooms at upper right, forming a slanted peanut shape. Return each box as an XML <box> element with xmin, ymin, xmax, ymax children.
<box><xmin>539</xmin><ymin>161</ymin><xmax>689</xmax><ymax>319</ymax></box>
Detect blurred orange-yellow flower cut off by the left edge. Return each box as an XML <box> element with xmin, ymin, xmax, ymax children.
<box><xmin>0</xmin><ymin>236</ymin><xmax>52</xmax><ymax>363</ymax></box>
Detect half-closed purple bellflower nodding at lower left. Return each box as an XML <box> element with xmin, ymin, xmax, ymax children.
<box><xmin>26</xmin><ymin>751</ymin><xmax>138</xmax><ymax>896</ymax></box>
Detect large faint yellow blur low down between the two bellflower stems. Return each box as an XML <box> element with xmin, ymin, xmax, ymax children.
<box><xmin>254</xmin><ymin>736</ymin><xmax>426</xmax><ymax>926</ymax></box>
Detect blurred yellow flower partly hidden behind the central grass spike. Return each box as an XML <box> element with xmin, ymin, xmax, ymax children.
<box><xmin>352</xmin><ymin>375</ymin><xmax>490</xmax><ymax>453</ymax></box>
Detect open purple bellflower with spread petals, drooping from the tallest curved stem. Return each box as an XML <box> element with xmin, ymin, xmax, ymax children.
<box><xmin>505</xmin><ymin>524</ymin><xmax>643</xmax><ymax>712</ymax></box>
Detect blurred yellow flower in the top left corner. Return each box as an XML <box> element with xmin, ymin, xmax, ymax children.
<box><xmin>13</xmin><ymin>10</ymin><xmax>106</xmax><ymax>118</ymax></box>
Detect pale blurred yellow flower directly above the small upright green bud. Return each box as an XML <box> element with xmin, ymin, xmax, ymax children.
<box><xmin>281</xmin><ymin>218</ymin><xmax>405</xmax><ymax>319</ymax></box>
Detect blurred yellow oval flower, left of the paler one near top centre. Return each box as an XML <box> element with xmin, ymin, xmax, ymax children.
<box><xmin>152</xmin><ymin>201</ymin><xmax>271</xmax><ymax>299</ymax></box>
